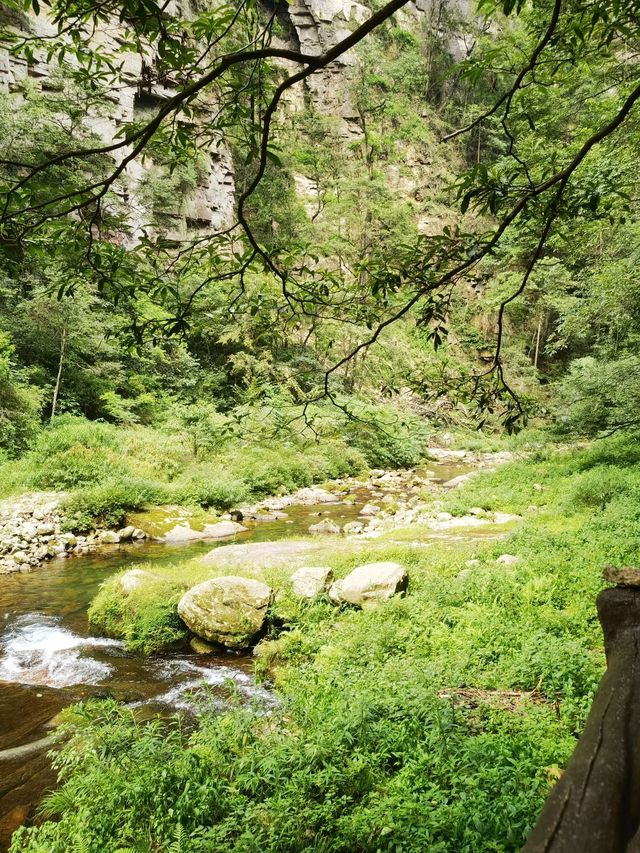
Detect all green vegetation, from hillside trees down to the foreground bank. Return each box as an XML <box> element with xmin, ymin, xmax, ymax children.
<box><xmin>0</xmin><ymin>0</ymin><xmax>640</xmax><ymax>853</ymax></box>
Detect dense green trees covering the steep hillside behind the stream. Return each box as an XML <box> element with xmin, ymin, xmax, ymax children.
<box><xmin>0</xmin><ymin>2</ymin><xmax>638</xmax><ymax>472</ymax></box>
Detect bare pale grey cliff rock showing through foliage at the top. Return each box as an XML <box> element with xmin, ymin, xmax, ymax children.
<box><xmin>0</xmin><ymin>0</ymin><xmax>471</xmax><ymax>239</ymax></box>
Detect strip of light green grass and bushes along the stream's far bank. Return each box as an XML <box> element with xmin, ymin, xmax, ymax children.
<box><xmin>0</xmin><ymin>403</ymin><xmax>548</xmax><ymax>532</ymax></box>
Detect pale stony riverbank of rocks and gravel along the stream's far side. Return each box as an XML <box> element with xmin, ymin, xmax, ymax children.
<box><xmin>0</xmin><ymin>447</ymin><xmax>514</xmax><ymax>575</ymax></box>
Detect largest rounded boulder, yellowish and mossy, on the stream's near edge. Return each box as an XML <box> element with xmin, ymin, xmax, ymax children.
<box><xmin>178</xmin><ymin>575</ymin><xmax>273</xmax><ymax>649</ymax></box>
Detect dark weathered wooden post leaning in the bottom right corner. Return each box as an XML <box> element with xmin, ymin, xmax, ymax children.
<box><xmin>523</xmin><ymin>586</ymin><xmax>640</xmax><ymax>853</ymax></box>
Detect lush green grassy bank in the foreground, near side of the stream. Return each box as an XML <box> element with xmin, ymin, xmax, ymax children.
<box><xmin>12</xmin><ymin>440</ymin><xmax>640</xmax><ymax>853</ymax></box>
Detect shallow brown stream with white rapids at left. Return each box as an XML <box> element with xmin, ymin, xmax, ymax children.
<box><xmin>0</xmin><ymin>462</ymin><xmax>488</xmax><ymax>851</ymax></box>
